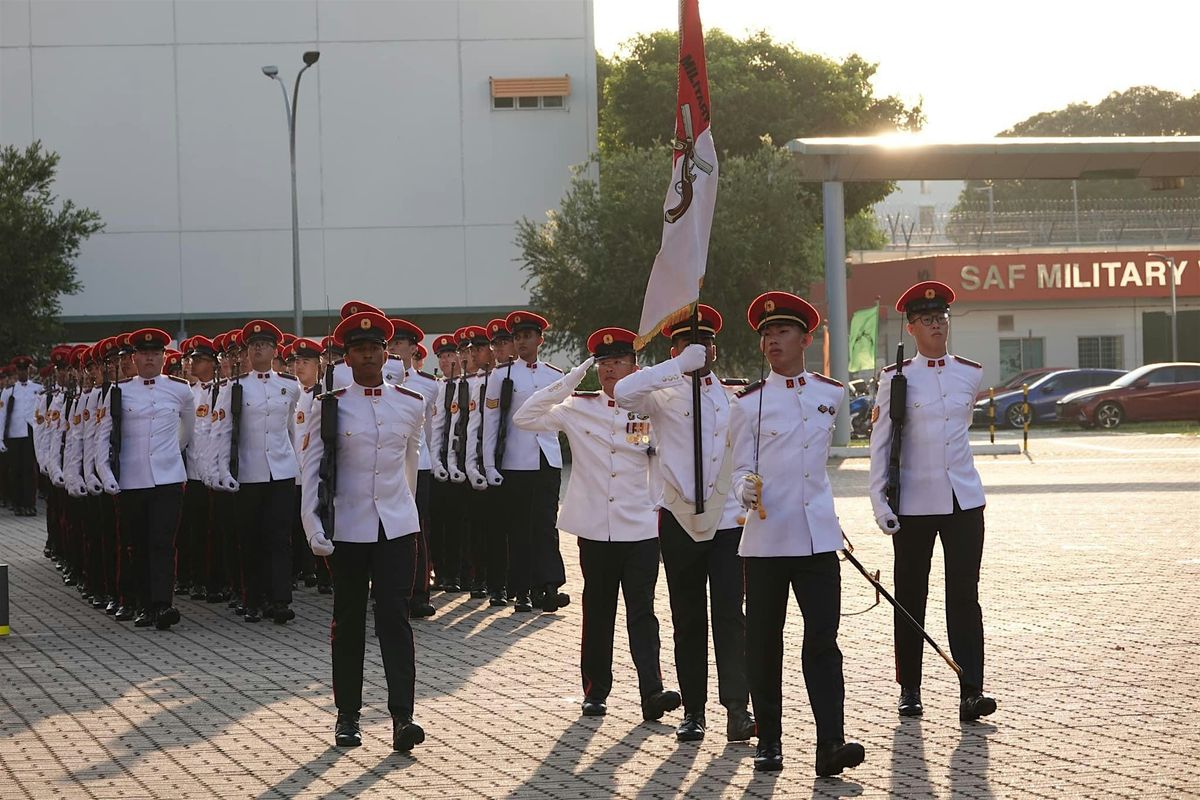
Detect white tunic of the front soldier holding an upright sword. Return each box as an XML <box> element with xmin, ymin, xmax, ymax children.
<box><xmin>732</xmin><ymin>372</ymin><xmax>846</xmax><ymax>557</ymax></box>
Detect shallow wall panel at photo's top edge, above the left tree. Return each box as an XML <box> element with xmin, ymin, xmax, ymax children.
<box><xmin>30</xmin><ymin>0</ymin><xmax>175</xmax><ymax>46</ymax></box>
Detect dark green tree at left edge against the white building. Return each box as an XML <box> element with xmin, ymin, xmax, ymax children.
<box><xmin>0</xmin><ymin>142</ymin><xmax>104</xmax><ymax>356</ymax></box>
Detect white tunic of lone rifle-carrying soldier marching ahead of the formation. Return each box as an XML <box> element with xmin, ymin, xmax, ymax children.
<box><xmin>300</xmin><ymin>384</ymin><xmax>425</xmax><ymax>542</ymax></box>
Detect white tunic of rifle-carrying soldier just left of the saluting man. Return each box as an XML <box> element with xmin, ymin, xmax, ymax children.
<box><xmin>484</xmin><ymin>359</ymin><xmax>563</xmax><ymax>470</ymax></box>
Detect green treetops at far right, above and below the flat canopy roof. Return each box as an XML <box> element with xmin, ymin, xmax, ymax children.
<box><xmin>958</xmin><ymin>86</ymin><xmax>1200</xmax><ymax>209</ymax></box>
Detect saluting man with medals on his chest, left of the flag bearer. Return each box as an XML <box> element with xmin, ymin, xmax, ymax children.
<box><xmin>512</xmin><ymin>327</ymin><xmax>680</xmax><ymax>720</ymax></box>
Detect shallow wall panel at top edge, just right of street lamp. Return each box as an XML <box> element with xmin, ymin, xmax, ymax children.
<box><xmin>317</xmin><ymin>0</ymin><xmax>458</xmax><ymax>42</ymax></box>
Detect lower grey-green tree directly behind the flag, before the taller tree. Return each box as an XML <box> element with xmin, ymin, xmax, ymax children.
<box><xmin>517</xmin><ymin>143</ymin><xmax>882</xmax><ymax>375</ymax></box>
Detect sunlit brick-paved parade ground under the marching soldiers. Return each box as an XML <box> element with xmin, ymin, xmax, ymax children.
<box><xmin>0</xmin><ymin>433</ymin><xmax>1200</xmax><ymax>800</ymax></box>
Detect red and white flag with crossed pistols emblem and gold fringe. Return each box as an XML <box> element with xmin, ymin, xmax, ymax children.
<box><xmin>634</xmin><ymin>0</ymin><xmax>718</xmax><ymax>350</ymax></box>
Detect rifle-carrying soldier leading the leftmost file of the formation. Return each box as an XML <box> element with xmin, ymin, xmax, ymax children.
<box><xmin>96</xmin><ymin>327</ymin><xmax>196</xmax><ymax>630</ymax></box>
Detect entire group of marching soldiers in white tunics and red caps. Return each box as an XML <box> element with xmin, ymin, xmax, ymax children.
<box><xmin>0</xmin><ymin>282</ymin><xmax>996</xmax><ymax>775</ymax></box>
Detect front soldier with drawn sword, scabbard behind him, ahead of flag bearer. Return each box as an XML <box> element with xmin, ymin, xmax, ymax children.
<box><xmin>731</xmin><ymin>291</ymin><xmax>865</xmax><ymax>776</ymax></box>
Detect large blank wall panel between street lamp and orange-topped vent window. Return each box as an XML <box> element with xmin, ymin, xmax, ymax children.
<box><xmin>319</xmin><ymin>42</ymin><xmax>462</xmax><ymax>228</ymax></box>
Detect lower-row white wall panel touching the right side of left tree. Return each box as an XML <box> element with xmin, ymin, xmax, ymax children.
<box><xmin>62</xmin><ymin>233</ymin><xmax>180</xmax><ymax>317</ymax></box>
